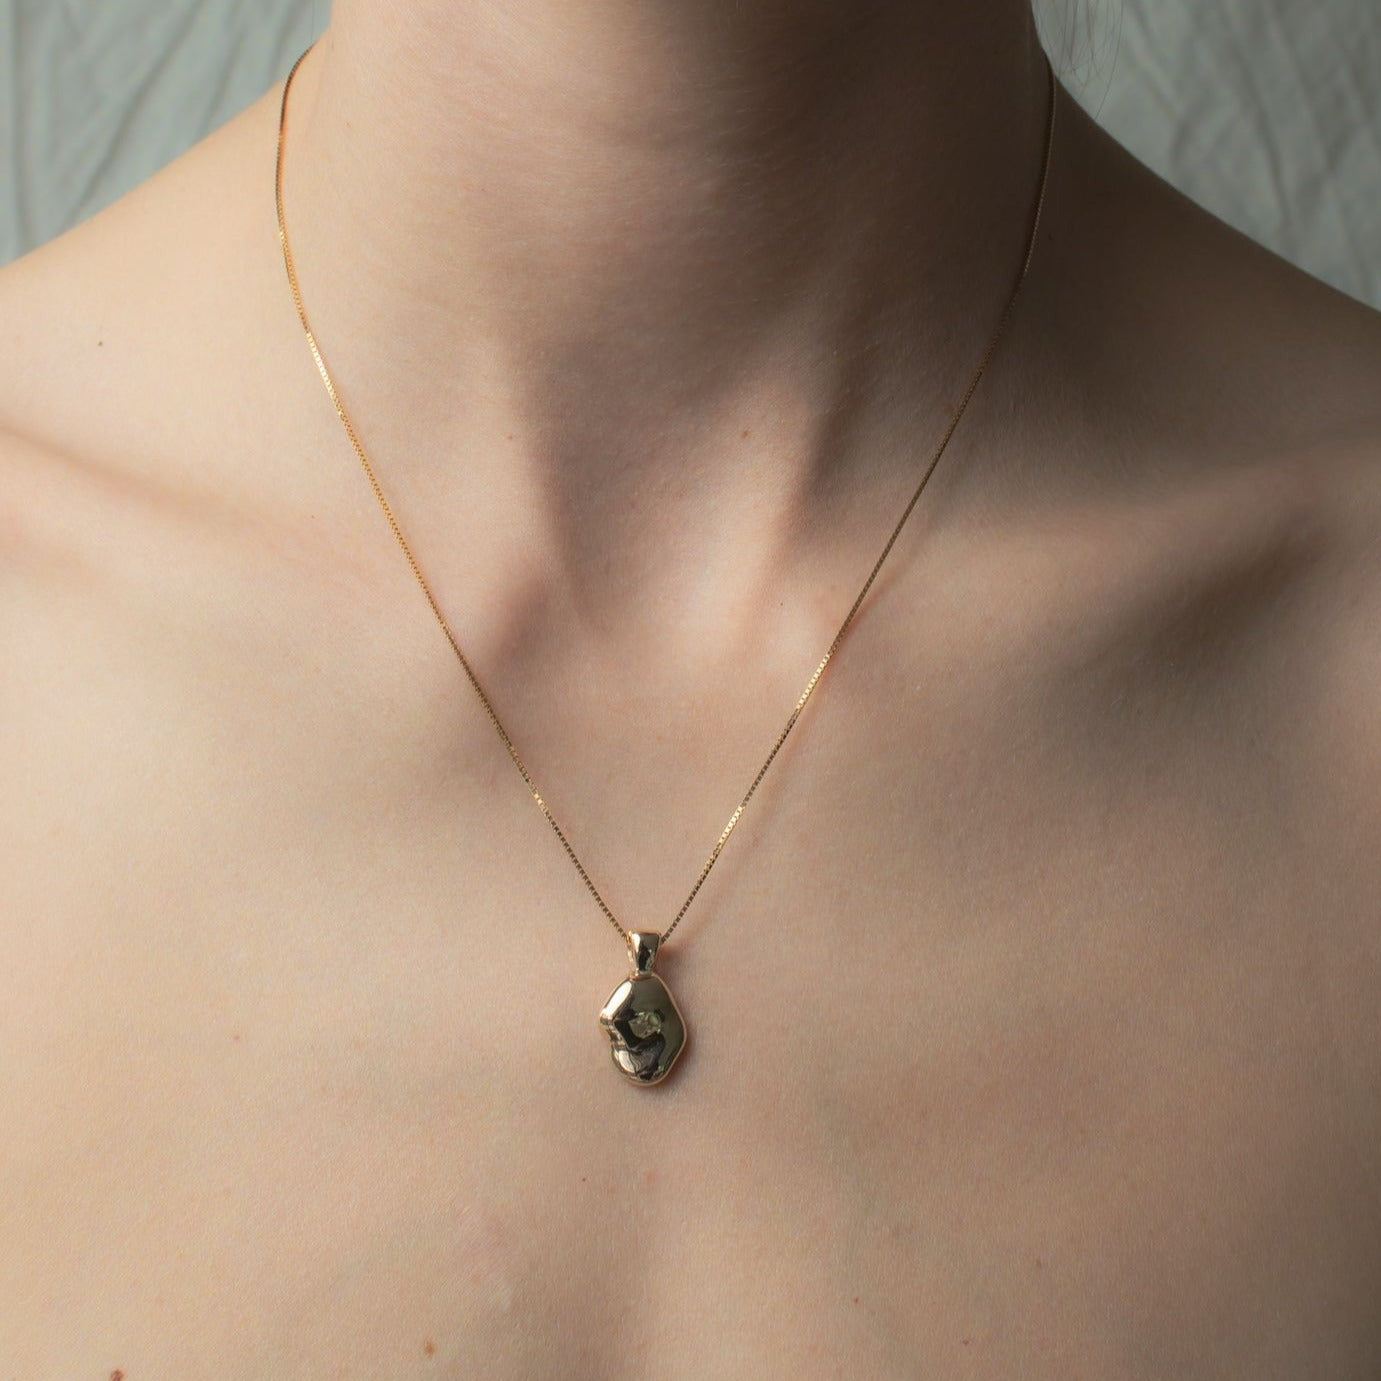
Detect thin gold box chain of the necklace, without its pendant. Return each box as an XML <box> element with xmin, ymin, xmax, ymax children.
<box><xmin>275</xmin><ymin>40</ymin><xmax>1058</xmax><ymax>945</ymax></box>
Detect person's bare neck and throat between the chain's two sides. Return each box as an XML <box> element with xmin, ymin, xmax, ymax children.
<box><xmin>284</xmin><ymin>0</ymin><xmax>1047</xmax><ymax>632</ymax></box>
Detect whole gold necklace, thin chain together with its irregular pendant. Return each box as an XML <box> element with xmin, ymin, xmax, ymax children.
<box><xmin>275</xmin><ymin>40</ymin><xmax>1059</xmax><ymax>1085</ymax></box>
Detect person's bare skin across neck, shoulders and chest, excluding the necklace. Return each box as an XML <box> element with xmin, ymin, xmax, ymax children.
<box><xmin>0</xmin><ymin>0</ymin><xmax>1381</xmax><ymax>1381</ymax></box>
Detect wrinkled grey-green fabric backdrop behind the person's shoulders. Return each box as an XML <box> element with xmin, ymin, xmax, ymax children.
<box><xmin>0</xmin><ymin>0</ymin><xmax>1381</xmax><ymax>307</ymax></box>
